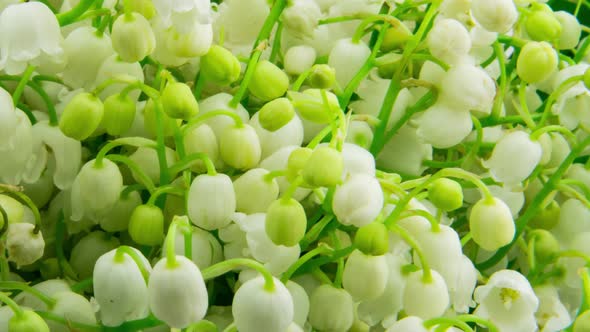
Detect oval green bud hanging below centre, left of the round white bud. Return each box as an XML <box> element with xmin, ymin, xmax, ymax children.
<box><xmin>265</xmin><ymin>198</ymin><xmax>307</xmax><ymax>247</ymax></box>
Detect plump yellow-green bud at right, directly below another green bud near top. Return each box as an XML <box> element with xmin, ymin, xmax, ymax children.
<box><xmin>516</xmin><ymin>42</ymin><xmax>557</xmax><ymax>83</ymax></box>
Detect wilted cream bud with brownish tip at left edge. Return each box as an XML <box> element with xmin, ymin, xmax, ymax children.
<box><xmin>6</xmin><ymin>223</ymin><xmax>45</xmax><ymax>267</ymax></box>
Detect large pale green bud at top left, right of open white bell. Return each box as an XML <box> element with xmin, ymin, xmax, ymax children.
<box><xmin>111</xmin><ymin>13</ymin><xmax>156</xmax><ymax>62</ymax></box>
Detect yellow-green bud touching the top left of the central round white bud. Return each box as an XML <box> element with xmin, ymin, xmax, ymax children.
<box><xmin>302</xmin><ymin>146</ymin><xmax>344</xmax><ymax>187</ymax></box>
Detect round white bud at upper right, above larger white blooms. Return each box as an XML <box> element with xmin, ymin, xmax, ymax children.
<box><xmin>427</xmin><ymin>18</ymin><xmax>471</xmax><ymax>65</ymax></box>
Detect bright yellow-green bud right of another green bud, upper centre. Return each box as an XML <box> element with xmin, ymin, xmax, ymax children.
<box><xmin>248</xmin><ymin>60</ymin><xmax>289</xmax><ymax>101</ymax></box>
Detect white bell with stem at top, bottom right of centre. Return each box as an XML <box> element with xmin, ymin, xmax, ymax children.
<box><xmin>403</xmin><ymin>270</ymin><xmax>449</xmax><ymax>319</ymax></box>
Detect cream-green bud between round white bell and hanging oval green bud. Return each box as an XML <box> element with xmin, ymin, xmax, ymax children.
<box><xmin>234</xmin><ymin>168</ymin><xmax>279</xmax><ymax>214</ymax></box>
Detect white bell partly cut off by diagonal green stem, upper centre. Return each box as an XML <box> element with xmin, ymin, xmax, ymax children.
<box><xmin>328</xmin><ymin>38</ymin><xmax>371</xmax><ymax>88</ymax></box>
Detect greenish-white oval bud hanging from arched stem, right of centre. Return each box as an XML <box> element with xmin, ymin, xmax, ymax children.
<box><xmin>469</xmin><ymin>197</ymin><xmax>516</xmax><ymax>251</ymax></box>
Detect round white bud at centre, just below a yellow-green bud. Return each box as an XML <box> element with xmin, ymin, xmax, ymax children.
<box><xmin>332</xmin><ymin>174</ymin><xmax>384</xmax><ymax>227</ymax></box>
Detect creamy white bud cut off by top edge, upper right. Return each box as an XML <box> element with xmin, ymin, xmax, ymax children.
<box><xmin>471</xmin><ymin>0</ymin><xmax>518</xmax><ymax>33</ymax></box>
